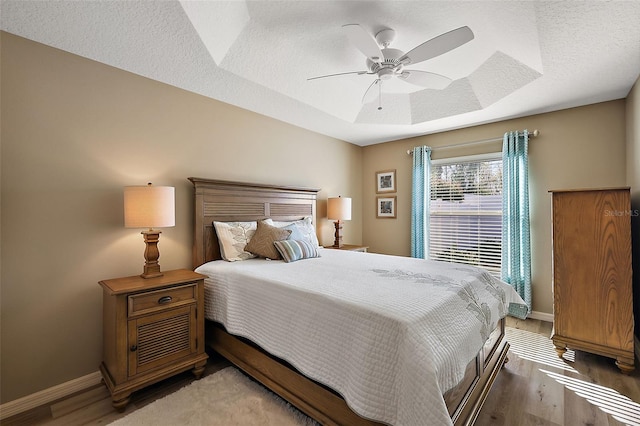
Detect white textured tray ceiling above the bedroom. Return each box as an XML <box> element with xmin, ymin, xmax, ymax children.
<box><xmin>0</xmin><ymin>0</ymin><xmax>640</xmax><ymax>146</ymax></box>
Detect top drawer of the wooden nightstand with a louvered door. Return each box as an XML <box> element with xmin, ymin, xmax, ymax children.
<box><xmin>127</xmin><ymin>283</ymin><xmax>197</xmax><ymax>317</ymax></box>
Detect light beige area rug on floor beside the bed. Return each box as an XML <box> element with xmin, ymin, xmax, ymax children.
<box><xmin>111</xmin><ymin>367</ymin><xmax>317</xmax><ymax>426</ymax></box>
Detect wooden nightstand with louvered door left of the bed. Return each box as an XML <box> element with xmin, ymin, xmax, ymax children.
<box><xmin>99</xmin><ymin>269</ymin><xmax>208</xmax><ymax>410</ymax></box>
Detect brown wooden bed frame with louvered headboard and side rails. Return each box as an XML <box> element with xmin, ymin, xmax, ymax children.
<box><xmin>189</xmin><ymin>177</ymin><xmax>509</xmax><ymax>426</ymax></box>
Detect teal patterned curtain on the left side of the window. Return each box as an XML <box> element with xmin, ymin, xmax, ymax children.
<box><xmin>411</xmin><ymin>146</ymin><xmax>431</xmax><ymax>259</ymax></box>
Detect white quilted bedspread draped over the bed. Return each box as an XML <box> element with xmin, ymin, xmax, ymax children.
<box><xmin>196</xmin><ymin>250</ymin><xmax>523</xmax><ymax>426</ymax></box>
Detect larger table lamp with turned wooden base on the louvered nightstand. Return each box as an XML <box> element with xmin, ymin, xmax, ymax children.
<box><xmin>124</xmin><ymin>183</ymin><xmax>176</xmax><ymax>278</ymax></box>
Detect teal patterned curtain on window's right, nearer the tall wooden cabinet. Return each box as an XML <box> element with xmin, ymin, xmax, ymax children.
<box><xmin>501</xmin><ymin>130</ymin><xmax>531</xmax><ymax>318</ymax></box>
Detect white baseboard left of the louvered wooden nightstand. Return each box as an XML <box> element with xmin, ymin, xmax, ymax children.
<box><xmin>0</xmin><ymin>371</ymin><xmax>102</xmax><ymax>420</ymax></box>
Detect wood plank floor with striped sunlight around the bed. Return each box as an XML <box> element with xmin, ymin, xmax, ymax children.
<box><xmin>2</xmin><ymin>318</ymin><xmax>640</xmax><ymax>426</ymax></box>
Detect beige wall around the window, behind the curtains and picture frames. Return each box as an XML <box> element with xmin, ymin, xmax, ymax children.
<box><xmin>362</xmin><ymin>100</ymin><xmax>637</xmax><ymax>313</ymax></box>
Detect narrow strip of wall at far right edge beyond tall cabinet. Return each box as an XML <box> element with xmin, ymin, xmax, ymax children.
<box><xmin>626</xmin><ymin>78</ymin><xmax>640</xmax><ymax>336</ymax></box>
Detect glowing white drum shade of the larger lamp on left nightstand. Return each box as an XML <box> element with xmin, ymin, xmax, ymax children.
<box><xmin>124</xmin><ymin>184</ymin><xmax>176</xmax><ymax>228</ymax></box>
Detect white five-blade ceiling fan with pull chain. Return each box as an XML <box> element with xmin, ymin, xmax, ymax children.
<box><xmin>307</xmin><ymin>24</ymin><xmax>474</xmax><ymax>110</ymax></box>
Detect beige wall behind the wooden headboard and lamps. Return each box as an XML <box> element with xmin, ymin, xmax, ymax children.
<box><xmin>1</xmin><ymin>33</ymin><xmax>362</xmax><ymax>402</ymax></box>
